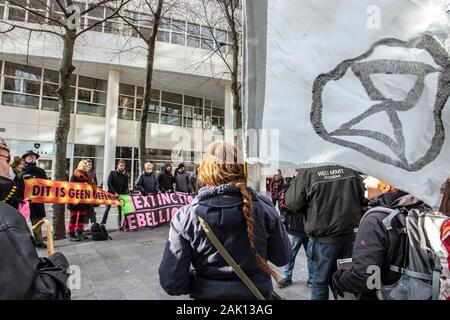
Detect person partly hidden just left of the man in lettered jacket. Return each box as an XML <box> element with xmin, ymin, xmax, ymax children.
<box><xmin>278</xmin><ymin>170</ymin><xmax>314</xmax><ymax>288</ymax></box>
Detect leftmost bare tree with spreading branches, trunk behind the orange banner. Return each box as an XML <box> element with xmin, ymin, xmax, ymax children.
<box><xmin>0</xmin><ymin>0</ymin><xmax>131</xmax><ymax>239</ymax></box>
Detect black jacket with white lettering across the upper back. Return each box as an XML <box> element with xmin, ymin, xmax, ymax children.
<box><xmin>286</xmin><ymin>166</ymin><xmax>365</xmax><ymax>243</ymax></box>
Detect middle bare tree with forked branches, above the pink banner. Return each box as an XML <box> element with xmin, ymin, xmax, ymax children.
<box><xmin>120</xmin><ymin>0</ymin><xmax>176</xmax><ymax>172</ymax></box>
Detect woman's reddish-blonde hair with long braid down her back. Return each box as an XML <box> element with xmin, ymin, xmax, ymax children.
<box><xmin>197</xmin><ymin>142</ymin><xmax>280</xmax><ymax>283</ymax></box>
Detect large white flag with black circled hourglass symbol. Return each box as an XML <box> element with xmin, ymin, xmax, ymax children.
<box><xmin>247</xmin><ymin>0</ymin><xmax>450</xmax><ymax>205</ymax></box>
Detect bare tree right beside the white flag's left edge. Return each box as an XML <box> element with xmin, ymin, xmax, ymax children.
<box><xmin>185</xmin><ymin>0</ymin><xmax>243</xmax><ymax>147</ymax></box>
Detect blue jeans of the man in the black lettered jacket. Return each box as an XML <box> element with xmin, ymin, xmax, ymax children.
<box><xmin>311</xmin><ymin>240</ymin><xmax>354</xmax><ymax>300</ymax></box>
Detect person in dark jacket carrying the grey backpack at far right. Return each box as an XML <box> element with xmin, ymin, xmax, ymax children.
<box><xmin>333</xmin><ymin>187</ymin><xmax>423</xmax><ymax>300</ymax></box>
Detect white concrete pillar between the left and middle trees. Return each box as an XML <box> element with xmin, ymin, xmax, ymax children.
<box><xmin>103</xmin><ymin>70</ymin><xmax>120</xmax><ymax>189</ymax></box>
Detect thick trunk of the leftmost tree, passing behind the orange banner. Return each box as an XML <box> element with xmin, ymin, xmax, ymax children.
<box><xmin>53</xmin><ymin>29</ymin><xmax>76</xmax><ymax>240</ymax></box>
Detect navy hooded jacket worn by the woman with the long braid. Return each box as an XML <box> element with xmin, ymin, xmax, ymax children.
<box><xmin>159</xmin><ymin>185</ymin><xmax>292</xmax><ymax>300</ymax></box>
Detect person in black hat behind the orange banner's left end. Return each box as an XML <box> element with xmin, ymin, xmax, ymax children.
<box><xmin>22</xmin><ymin>150</ymin><xmax>48</xmax><ymax>248</ymax></box>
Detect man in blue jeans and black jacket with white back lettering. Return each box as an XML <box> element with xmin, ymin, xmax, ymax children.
<box><xmin>286</xmin><ymin>166</ymin><xmax>365</xmax><ymax>300</ymax></box>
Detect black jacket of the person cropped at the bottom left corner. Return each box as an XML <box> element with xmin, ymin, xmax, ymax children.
<box><xmin>0</xmin><ymin>203</ymin><xmax>70</xmax><ymax>300</ymax></box>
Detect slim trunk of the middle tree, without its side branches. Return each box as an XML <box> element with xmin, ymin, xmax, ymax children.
<box><xmin>139</xmin><ymin>0</ymin><xmax>164</xmax><ymax>172</ymax></box>
